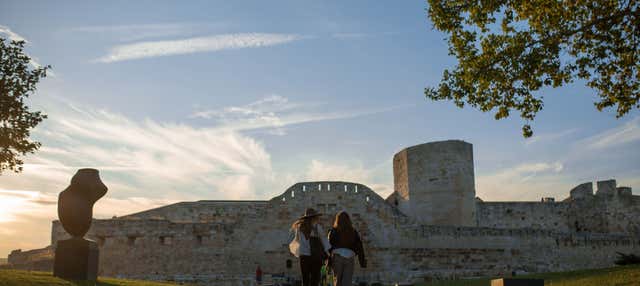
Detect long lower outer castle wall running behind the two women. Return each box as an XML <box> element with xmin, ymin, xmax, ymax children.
<box><xmin>52</xmin><ymin>216</ymin><xmax>640</xmax><ymax>283</ymax></box>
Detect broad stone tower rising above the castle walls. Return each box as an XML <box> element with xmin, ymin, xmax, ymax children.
<box><xmin>393</xmin><ymin>140</ymin><xmax>476</xmax><ymax>226</ymax></box>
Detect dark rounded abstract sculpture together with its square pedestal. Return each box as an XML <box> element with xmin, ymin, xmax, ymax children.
<box><xmin>53</xmin><ymin>169</ymin><xmax>107</xmax><ymax>281</ymax></box>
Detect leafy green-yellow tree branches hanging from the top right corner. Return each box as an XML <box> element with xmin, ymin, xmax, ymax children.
<box><xmin>425</xmin><ymin>0</ymin><xmax>640</xmax><ymax>137</ymax></box>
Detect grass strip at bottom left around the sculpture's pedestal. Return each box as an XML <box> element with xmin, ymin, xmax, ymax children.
<box><xmin>0</xmin><ymin>270</ymin><xmax>182</xmax><ymax>286</ymax></box>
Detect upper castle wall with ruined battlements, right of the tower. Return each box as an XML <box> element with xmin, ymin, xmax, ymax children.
<box><xmin>476</xmin><ymin>180</ymin><xmax>640</xmax><ymax>235</ymax></box>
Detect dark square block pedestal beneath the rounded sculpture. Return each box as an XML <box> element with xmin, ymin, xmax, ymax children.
<box><xmin>53</xmin><ymin>237</ymin><xmax>98</xmax><ymax>281</ymax></box>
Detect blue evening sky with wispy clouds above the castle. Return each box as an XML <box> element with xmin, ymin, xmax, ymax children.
<box><xmin>0</xmin><ymin>0</ymin><xmax>640</xmax><ymax>257</ymax></box>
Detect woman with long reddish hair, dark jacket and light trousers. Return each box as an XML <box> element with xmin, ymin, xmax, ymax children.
<box><xmin>329</xmin><ymin>211</ymin><xmax>367</xmax><ymax>286</ymax></box>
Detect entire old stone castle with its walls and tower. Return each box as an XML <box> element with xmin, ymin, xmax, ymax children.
<box><xmin>10</xmin><ymin>140</ymin><xmax>640</xmax><ymax>285</ymax></box>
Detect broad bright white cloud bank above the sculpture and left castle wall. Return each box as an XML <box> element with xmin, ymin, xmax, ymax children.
<box><xmin>0</xmin><ymin>96</ymin><xmax>284</xmax><ymax>199</ymax></box>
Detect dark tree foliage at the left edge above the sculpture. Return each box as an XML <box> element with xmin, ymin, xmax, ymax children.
<box><xmin>0</xmin><ymin>38</ymin><xmax>51</xmax><ymax>173</ymax></box>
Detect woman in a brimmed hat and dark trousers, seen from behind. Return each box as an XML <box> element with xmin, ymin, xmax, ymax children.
<box><xmin>289</xmin><ymin>208</ymin><xmax>331</xmax><ymax>286</ymax></box>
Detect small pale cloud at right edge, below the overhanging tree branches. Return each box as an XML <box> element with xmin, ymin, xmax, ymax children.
<box><xmin>579</xmin><ymin>116</ymin><xmax>640</xmax><ymax>149</ymax></box>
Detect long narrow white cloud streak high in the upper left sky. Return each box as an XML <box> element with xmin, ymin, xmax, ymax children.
<box><xmin>95</xmin><ymin>33</ymin><xmax>304</xmax><ymax>63</ymax></box>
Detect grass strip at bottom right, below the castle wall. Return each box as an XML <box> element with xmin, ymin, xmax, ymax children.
<box><xmin>421</xmin><ymin>265</ymin><xmax>640</xmax><ymax>286</ymax></box>
